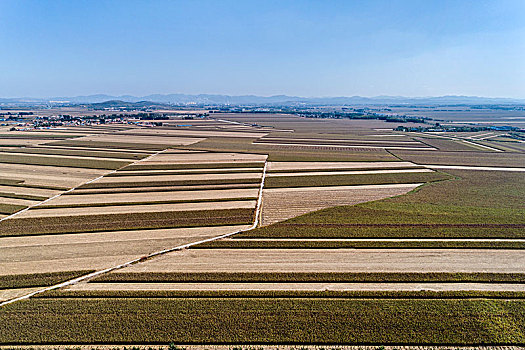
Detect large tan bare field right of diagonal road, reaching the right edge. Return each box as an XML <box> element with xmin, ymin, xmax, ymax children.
<box><xmin>121</xmin><ymin>249</ymin><xmax>525</xmax><ymax>273</ymax></box>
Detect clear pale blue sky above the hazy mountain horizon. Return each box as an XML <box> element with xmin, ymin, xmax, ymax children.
<box><xmin>0</xmin><ymin>0</ymin><xmax>525</xmax><ymax>98</ymax></box>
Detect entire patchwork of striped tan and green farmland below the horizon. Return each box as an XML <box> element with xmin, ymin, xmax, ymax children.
<box><xmin>0</xmin><ymin>109</ymin><xmax>525</xmax><ymax>347</ymax></box>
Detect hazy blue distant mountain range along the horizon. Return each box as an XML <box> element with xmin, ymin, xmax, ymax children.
<box><xmin>0</xmin><ymin>94</ymin><xmax>525</xmax><ymax>105</ymax></box>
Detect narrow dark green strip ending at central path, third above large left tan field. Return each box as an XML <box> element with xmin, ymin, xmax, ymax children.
<box><xmin>78</xmin><ymin>177</ymin><xmax>261</xmax><ymax>188</ymax></box>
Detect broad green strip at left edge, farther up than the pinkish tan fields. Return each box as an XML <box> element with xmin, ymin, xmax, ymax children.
<box><xmin>0</xmin><ymin>153</ymin><xmax>129</xmax><ymax>169</ymax></box>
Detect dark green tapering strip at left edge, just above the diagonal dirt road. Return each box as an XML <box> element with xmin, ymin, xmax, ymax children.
<box><xmin>0</xmin><ymin>270</ymin><xmax>94</xmax><ymax>289</ymax></box>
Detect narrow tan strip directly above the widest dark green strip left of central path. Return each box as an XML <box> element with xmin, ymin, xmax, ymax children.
<box><xmin>17</xmin><ymin>200</ymin><xmax>256</xmax><ymax>219</ymax></box>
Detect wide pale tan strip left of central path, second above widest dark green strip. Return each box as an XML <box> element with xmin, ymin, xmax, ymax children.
<box><xmin>44</xmin><ymin>186</ymin><xmax>259</xmax><ymax>205</ymax></box>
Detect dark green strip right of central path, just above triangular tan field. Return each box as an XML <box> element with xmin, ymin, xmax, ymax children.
<box><xmin>265</xmin><ymin>172</ymin><xmax>450</xmax><ymax>188</ymax></box>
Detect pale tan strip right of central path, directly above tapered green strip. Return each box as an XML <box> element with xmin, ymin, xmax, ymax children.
<box><xmin>268</xmin><ymin>162</ymin><xmax>418</xmax><ymax>172</ymax></box>
